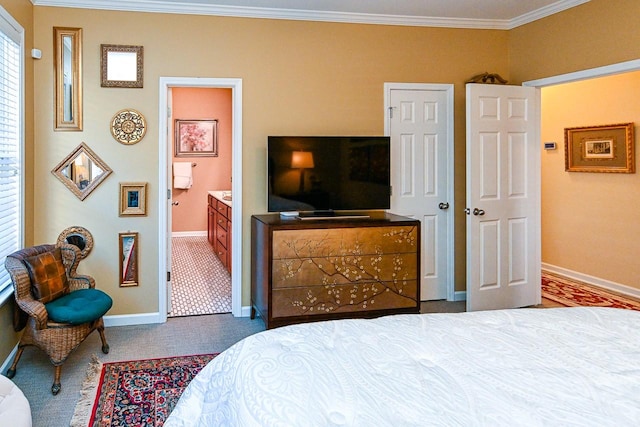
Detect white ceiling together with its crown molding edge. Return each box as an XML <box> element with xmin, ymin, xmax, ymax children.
<box><xmin>31</xmin><ymin>0</ymin><xmax>589</xmax><ymax>29</ymax></box>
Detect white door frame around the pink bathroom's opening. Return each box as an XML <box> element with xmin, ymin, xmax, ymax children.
<box><xmin>158</xmin><ymin>77</ymin><xmax>243</xmax><ymax>322</ymax></box>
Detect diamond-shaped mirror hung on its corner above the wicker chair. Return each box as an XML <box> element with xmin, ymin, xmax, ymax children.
<box><xmin>51</xmin><ymin>142</ymin><xmax>112</xmax><ymax>200</ymax></box>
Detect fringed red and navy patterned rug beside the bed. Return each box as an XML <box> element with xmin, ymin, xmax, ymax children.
<box><xmin>71</xmin><ymin>353</ymin><xmax>218</xmax><ymax>427</ymax></box>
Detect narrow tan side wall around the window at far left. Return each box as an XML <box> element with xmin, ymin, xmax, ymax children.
<box><xmin>0</xmin><ymin>0</ymin><xmax>34</xmax><ymax>363</ymax></box>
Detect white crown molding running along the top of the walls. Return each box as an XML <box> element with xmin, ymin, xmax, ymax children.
<box><xmin>31</xmin><ymin>0</ymin><xmax>590</xmax><ymax>30</ymax></box>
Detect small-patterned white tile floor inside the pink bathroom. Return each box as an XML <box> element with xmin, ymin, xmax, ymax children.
<box><xmin>169</xmin><ymin>236</ymin><xmax>231</xmax><ymax>317</ymax></box>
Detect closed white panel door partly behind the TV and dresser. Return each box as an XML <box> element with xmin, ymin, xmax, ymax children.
<box><xmin>385</xmin><ymin>83</ymin><xmax>454</xmax><ymax>301</ymax></box>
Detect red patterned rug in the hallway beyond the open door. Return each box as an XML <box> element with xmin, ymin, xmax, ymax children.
<box><xmin>542</xmin><ymin>271</ymin><xmax>640</xmax><ymax>311</ymax></box>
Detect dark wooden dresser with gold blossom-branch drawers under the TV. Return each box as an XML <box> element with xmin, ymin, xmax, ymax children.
<box><xmin>251</xmin><ymin>212</ymin><xmax>420</xmax><ymax>329</ymax></box>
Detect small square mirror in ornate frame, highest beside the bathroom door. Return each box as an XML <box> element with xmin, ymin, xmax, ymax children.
<box><xmin>100</xmin><ymin>44</ymin><xmax>144</xmax><ymax>88</ymax></box>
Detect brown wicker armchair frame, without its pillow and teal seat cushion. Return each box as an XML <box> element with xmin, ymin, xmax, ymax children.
<box><xmin>5</xmin><ymin>243</ymin><xmax>109</xmax><ymax>395</ymax></box>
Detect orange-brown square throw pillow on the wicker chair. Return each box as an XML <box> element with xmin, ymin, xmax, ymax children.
<box><xmin>24</xmin><ymin>248</ymin><xmax>69</xmax><ymax>304</ymax></box>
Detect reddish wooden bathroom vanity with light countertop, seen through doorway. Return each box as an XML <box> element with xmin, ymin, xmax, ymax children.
<box><xmin>207</xmin><ymin>191</ymin><xmax>231</xmax><ymax>273</ymax></box>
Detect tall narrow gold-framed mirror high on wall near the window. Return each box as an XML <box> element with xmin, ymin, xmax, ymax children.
<box><xmin>53</xmin><ymin>27</ymin><xmax>82</xmax><ymax>131</ymax></box>
